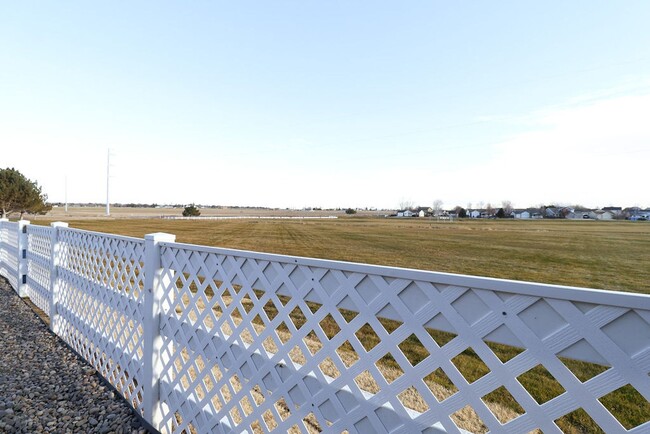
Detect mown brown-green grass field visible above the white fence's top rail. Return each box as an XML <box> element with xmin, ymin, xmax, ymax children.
<box><xmin>34</xmin><ymin>217</ymin><xmax>650</xmax><ymax>293</ymax></box>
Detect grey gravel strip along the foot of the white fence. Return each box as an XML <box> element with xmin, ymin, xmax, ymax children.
<box><xmin>0</xmin><ymin>278</ymin><xmax>153</xmax><ymax>434</ymax></box>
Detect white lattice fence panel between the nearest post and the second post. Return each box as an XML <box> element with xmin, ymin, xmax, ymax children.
<box><xmin>57</xmin><ymin>228</ymin><xmax>144</xmax><ymax>412</ymax></box>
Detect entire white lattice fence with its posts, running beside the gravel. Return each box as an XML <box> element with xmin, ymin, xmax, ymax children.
<box><xmin>0</xmin><ymin>220</ymin><xmax>650</xmax><ymax>434</ymax></box>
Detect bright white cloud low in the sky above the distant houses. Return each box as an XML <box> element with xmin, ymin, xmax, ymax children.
<box><xmin>470</xmin><ymin>95</ymin><xmax>650</xmax><ymax>206</ymax></box>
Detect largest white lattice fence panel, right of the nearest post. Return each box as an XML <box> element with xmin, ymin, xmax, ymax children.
<box><xmin>156</xmin><ymin>243</ymin><xmax>650</xmax><ymax>434</ymax></box>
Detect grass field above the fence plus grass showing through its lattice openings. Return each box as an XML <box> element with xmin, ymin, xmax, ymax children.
<box><xmin>29</xmin><ymin>213</ymin><xmax>650</xmax><ymax>433</ymax></box>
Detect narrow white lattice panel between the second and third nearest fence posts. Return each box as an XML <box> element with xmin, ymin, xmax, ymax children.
<box><xmin>26</xmin><ymin>225</ymin><xmax>52</xmax><ymax>316</ymax></box>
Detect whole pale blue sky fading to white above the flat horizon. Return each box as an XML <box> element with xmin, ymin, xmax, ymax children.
<box><xmin>0</xmin><ymin>0</ymin><xmax>650</xmax><ymax>208</ymax></box>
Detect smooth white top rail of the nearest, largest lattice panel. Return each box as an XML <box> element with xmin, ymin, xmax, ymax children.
<box><xmin>160</xmin><ymin>242</ymin><xmax>650</xmax><ymax>310</ymax></box>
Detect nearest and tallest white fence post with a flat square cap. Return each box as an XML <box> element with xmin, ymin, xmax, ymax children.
<box><xmin>143</xmin><ymin>233</ymin><xmax>176</xmax><ymax>429</ymax></box>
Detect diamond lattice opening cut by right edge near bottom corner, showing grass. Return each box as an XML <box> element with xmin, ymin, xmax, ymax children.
<box><xmin>599</xmin><ymin>384</ymin><xmax>650</xmax><ymax>430</ymax></box>
